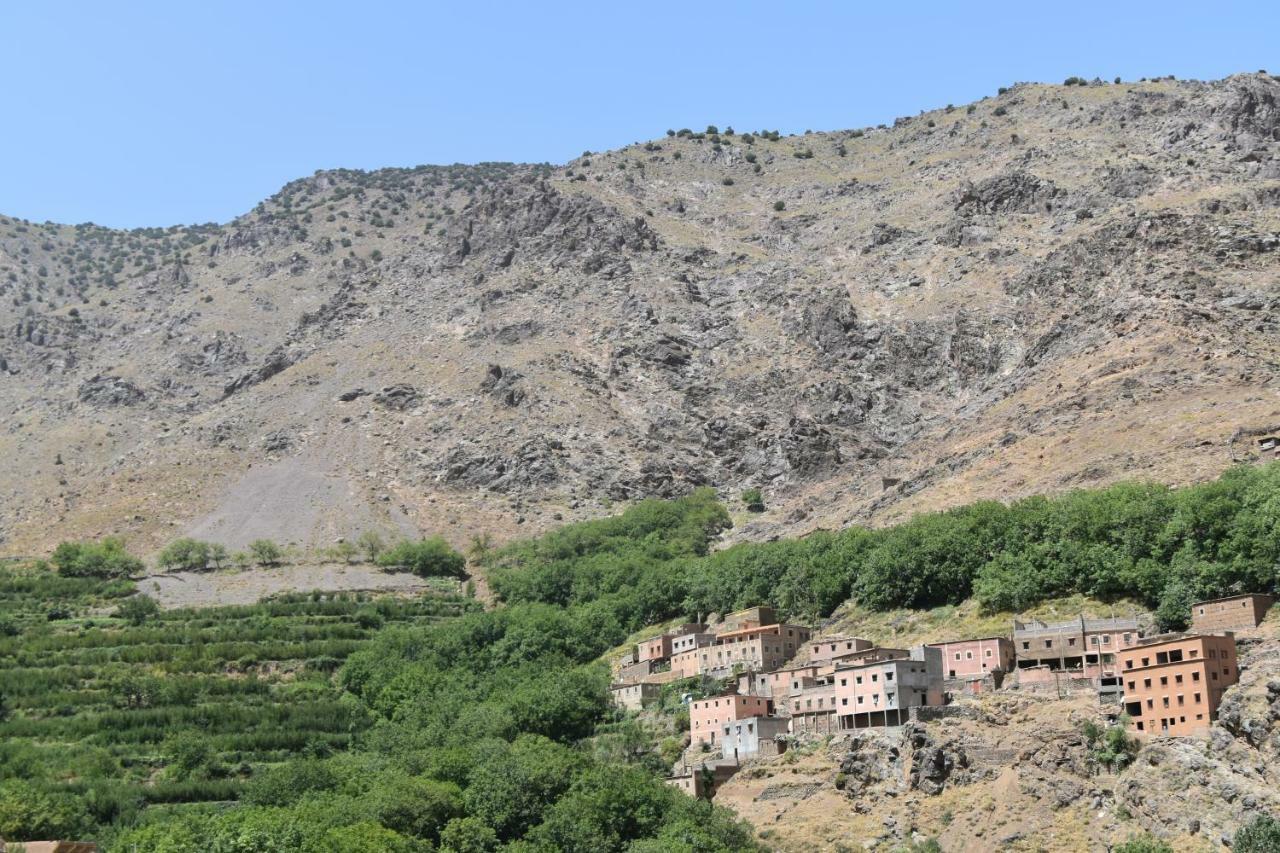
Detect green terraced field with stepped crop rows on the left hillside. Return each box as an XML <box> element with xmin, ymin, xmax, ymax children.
<box><xmin>0</xmin><ymin>567</ymin><xmax>476</xmax><ymax>822</ymax></box>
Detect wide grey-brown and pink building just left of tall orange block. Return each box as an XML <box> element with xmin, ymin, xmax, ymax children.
<box><xmin>1014</xmin><ymin>616</ymin><xmax>1142</xmax><ymax>679</ymax></box>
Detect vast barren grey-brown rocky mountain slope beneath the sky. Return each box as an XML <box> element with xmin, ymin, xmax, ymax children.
<box><xmin>0</xmin><ymin>73</ymin><xmax>1280</xmax><ymax>553</ymax></box>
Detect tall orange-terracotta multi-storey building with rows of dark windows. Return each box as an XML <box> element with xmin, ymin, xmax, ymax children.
<box><xmin>1120</xmin><ymin>633</ymin><xmax>1239</xmax><ymax>736</ymax></box>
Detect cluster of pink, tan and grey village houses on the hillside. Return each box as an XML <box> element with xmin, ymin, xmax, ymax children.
<box><xmin>611</xmin><ymin>594</ymin><xmax>1274</xmax><ymax>798</ymax></box>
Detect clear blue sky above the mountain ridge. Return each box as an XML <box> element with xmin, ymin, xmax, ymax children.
<box><xmin>0</xmin><ymin>0</ymin><xmax>1280</xmax><ymax>227</ymax></box>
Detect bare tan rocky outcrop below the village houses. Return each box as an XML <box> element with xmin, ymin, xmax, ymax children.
<box><xmin>716</xmin><ymin>613</ymin><xmax>1280</xmax><ymax>853</ymax></box>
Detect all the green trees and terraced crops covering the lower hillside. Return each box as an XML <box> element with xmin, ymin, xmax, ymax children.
<box><xmin>0</xmin><ymin>465</ymin><xmax>1280</xmax><ymax>853</ymax></box>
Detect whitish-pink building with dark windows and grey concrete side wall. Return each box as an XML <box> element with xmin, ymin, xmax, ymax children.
<box><xmin>834</xmin><ymin>646</ymin><xmax>946</xmax><ymax>729</ymax></box>
